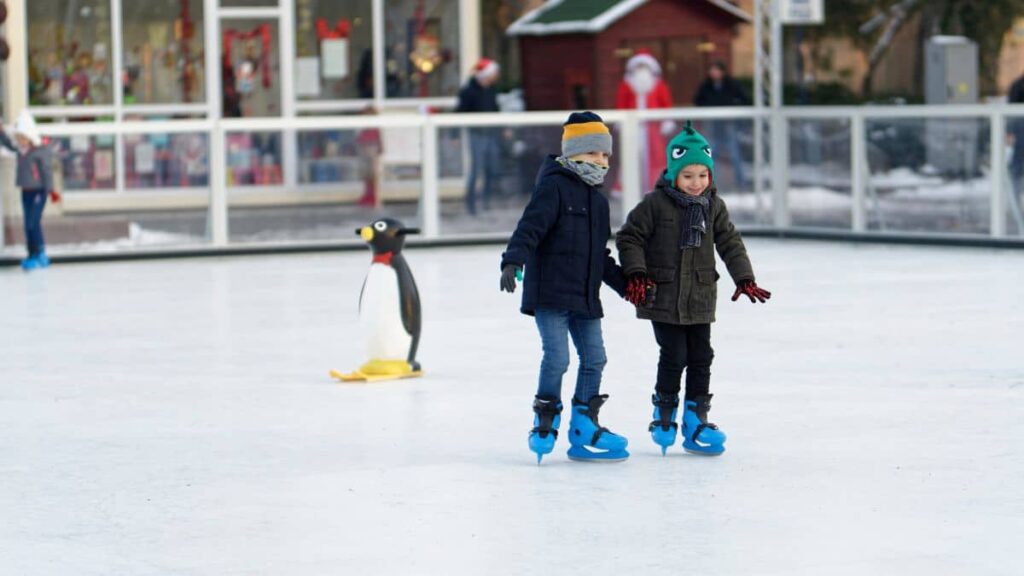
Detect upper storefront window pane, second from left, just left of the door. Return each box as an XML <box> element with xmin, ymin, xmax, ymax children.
<box><xmin>121</xmin><ymin>0</ymin><xmax>206</xmax><ymax>105</ymax></box>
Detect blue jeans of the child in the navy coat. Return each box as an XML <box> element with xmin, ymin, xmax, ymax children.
<box><xmin>536</xmin><ymin>310</ymin><xmax>608</xmax><ymax>402</ymax></box>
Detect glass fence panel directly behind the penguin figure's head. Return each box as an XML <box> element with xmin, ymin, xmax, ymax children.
<box><xmin>228</xmin><ymin>126</ymin><xmax>423</xmax><ymax>243</ymax></box>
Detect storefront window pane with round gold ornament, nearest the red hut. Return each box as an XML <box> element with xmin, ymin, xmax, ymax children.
<box><xmin>384</xmin><ymin>0</ymin><xmax>461</xmax><ymax>98</ymax></box>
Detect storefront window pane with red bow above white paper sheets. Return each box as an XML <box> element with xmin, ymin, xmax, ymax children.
<box><xmin>295</xmin><ymin>0</ymin><xmax>374</xmax><ymax>100</ymax></box>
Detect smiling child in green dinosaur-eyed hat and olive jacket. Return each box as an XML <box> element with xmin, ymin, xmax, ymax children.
<box><xmin>615</xmin><ymin>122</ymin><xmax>771</xmax><ymax>456</ymax></box>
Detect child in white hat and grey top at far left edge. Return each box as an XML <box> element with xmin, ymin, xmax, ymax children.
<box><xmin>0</xmin><ymin>111</ymin><xmax>60</xmax><ymax>271</ymax></box>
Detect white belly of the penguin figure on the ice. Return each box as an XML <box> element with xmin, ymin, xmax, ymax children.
<box><xmin>359</xmin><ymin>263</ymin><xmax>413</xmax><ymax>360</ymax></box>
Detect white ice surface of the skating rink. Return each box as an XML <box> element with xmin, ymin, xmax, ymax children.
<box><xmin>0</xmin><ymin>239</ymin><xmax>1024</xmax><ymax>576</ymax></box>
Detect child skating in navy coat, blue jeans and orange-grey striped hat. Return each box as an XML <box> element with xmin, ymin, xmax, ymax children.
<box><xmin>501</xmin><ymin>112</ymin><xmax>629</xmax><ymax>463</ymax></box>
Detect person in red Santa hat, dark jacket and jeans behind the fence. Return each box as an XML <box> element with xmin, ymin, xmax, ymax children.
<box><xmin>455</xmin><ymin>58</ymin><xmax>501</xmax><ymax>214</ymax></box>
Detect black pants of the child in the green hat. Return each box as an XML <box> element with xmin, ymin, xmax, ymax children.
<box><xmin>651</xmin><ymin>322</ymin><xmax>715</xmax><ymax>400</ymax></box>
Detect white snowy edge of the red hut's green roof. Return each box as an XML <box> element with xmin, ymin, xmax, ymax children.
<box><xmin>506</xmin><ymin>0</ymin><xmax>754</xmax><ymax>36</ymax></box>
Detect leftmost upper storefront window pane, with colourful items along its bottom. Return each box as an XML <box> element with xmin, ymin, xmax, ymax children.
<box><xmin>26</xmin><ymin>0</ymin><xmax>114</xmax><ymax>106</ymax></box>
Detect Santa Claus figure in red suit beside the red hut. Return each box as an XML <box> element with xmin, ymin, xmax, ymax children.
<box><xmin>615</xmin><ymin>49</ymin><xmax>675</xmax><ymax>192</ymax></box>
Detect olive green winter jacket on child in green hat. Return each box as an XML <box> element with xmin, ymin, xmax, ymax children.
<box><xmin>615</xmin><ymin>179</ymin><xmax>754</xmax><ymax>324</ymax></box>
